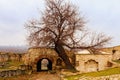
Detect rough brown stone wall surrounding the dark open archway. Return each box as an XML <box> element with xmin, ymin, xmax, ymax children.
<box><xmin>22</xmin><ymin>48</ymin><xmax>58</xmax><ymax>70</ymax></box>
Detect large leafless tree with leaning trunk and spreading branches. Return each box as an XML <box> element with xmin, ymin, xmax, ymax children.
<box><xmin>26</xmin><ymin>0</ymin><xmax>111</xmax><ymax>70</ymax></box>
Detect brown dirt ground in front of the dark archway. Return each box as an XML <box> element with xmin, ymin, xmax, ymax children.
<box><xmin>0</xmin><ymin>72</ymin><xmax>61</xmax><ymax>80</ymax></box>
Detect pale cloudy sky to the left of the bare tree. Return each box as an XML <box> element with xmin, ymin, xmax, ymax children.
<box><xmin>0</xmin><ymin>0</ymin><xmax>43</xmax><ymax>45</ymax></box>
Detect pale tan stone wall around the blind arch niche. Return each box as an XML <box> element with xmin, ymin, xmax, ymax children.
<box><xmin>76</xmin><ymin>54</ymin><xmax>112</xmax><ymax>72</ymax></box>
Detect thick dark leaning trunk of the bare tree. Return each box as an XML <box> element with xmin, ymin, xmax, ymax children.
<box><xmin>55</xmin><ymin>43</ymin><xmax>76</xmax><ymax>71</ymax></box>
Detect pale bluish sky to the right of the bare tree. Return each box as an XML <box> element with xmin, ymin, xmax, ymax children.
<box><xmin>71</xmin><ymin>0</ymin><xmax>120</xmax><ymax>45</ymax></box>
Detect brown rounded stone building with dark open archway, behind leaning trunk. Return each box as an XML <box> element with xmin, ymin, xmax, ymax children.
<box><xmin>23</xmin><ymin>47</ymin><xmax>74</xmax><ymax>72</ymax></box>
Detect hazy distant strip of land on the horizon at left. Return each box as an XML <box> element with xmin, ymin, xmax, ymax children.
<box><xmin>0</xmin><ymin>46</ymin><xmax>28</xmax><ymax>53</ymax></box>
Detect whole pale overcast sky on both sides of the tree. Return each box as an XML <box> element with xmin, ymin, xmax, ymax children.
<box><xmin>0</xmin><ymin>0</ymin><xmax>120</xmax><ymax>46</ymax></box>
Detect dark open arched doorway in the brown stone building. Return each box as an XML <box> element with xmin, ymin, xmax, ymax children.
<box><xmin>37</xmin><ymin>58</ymin><xmax>52</xmax><ymax>72</ymax></box>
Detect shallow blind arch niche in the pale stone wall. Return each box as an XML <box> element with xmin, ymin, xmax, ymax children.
<box><xmin>85</xmin><ymin>59</ymin><xmax>98</xmax><ymax>72</ymax></box>
